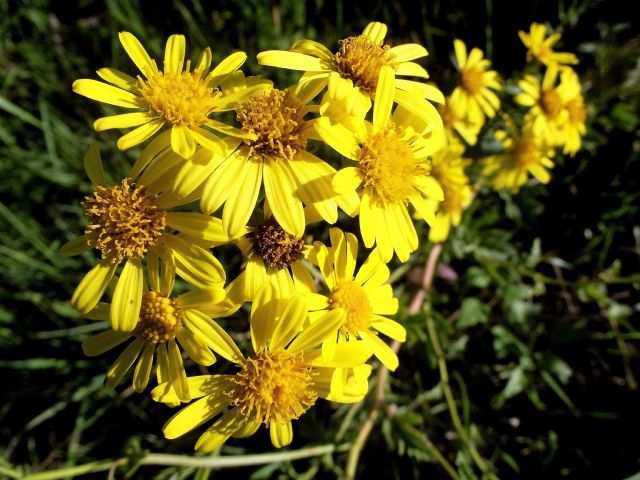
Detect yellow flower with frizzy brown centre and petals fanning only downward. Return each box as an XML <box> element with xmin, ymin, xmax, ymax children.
<box><xmin>200</xmin><ymin>76</ymin><xmax>357</xmax><ymax>238</ymax></box>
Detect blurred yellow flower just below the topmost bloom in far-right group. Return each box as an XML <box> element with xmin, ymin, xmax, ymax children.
<box><xmin>514</xmin><ymin>66</ymin><xmax>569</xmax><ymax>145</ymax></box>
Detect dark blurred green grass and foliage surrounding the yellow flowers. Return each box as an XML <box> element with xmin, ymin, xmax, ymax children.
<box><xmin>0</xmin><ymin>0</ymin><xmax>640</xmax><ymax>480</ymax></box>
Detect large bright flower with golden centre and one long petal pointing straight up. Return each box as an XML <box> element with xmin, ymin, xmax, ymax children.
<box><xmin>315</xmin><ymin>66</ymin><xmax>444</xmax><ymax>262</ymax></box>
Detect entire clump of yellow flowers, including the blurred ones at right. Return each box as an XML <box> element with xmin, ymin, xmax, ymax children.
<box><xmin>61</xmin><ymin>22</ymin><xmax>586</xmax><ymax>452</ymax></box>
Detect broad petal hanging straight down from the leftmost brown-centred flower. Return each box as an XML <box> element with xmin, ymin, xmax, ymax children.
<box><xmin>111</xmin><ymin>260</ymin><xmax>143</xmax><ymax>332</ymax></box>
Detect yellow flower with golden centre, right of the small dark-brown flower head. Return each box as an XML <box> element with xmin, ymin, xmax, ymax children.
<box><xmin>308</xmin><ymin>228</ymin><xmax>407</xmax><ymax>370</ymax></box>
